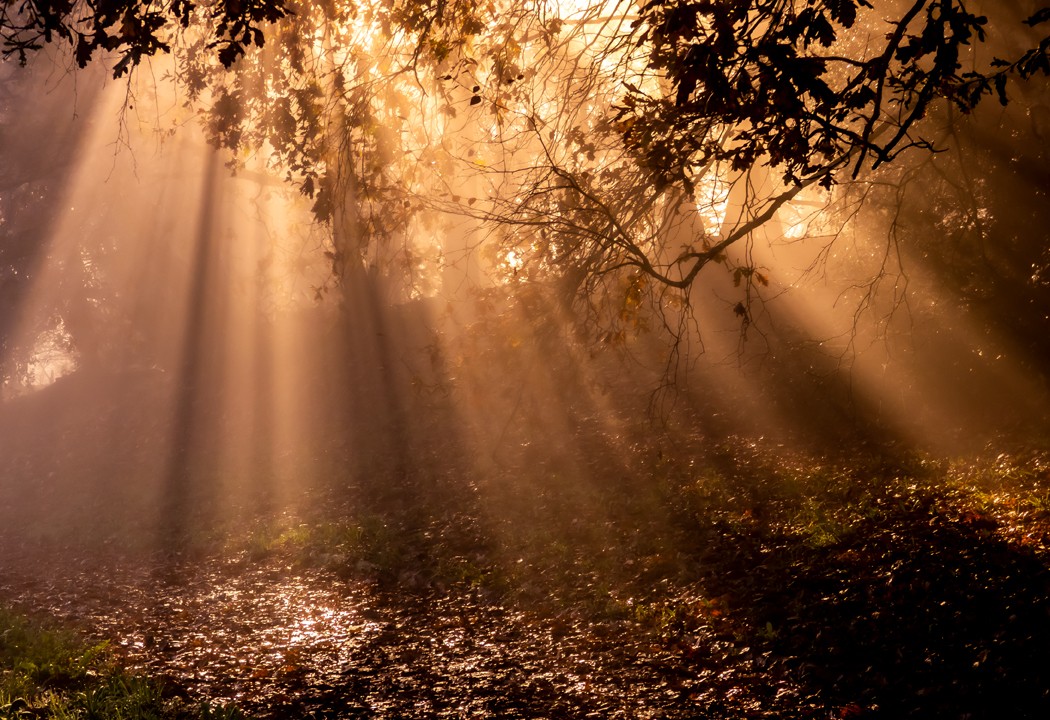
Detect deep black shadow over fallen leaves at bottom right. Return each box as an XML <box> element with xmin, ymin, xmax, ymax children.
<box><xmin>702</xmin><ymin>488</ymin><xmax>1050</xmax><ymax>719</ymax></box>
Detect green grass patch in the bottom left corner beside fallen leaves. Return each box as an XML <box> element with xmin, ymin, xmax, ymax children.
<box><xmin>0</xmin><ymin>609</ymin><xmax>245</xmax><ymax>720</ymax></box>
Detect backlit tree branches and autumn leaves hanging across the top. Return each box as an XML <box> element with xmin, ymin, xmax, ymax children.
<box><xmin>0</xmin><ymin>0</ymin><xmax>1050</xmax><ymax>338</ymax></box>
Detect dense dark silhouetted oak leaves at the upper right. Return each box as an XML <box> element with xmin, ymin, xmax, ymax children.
<box><xmin>621</xmin><ymin>0</ymin><xmax>1050</xmax><ymax>192</ymax></box>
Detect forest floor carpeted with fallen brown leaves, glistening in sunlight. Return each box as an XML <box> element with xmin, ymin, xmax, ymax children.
<box><xmin>0</xmin><ymin>432</ymin><xmax>1050</xmax><ymax>719</ymax></box>
